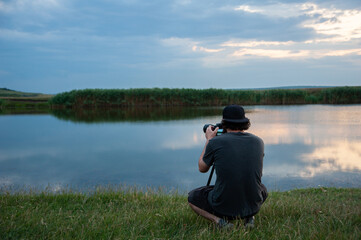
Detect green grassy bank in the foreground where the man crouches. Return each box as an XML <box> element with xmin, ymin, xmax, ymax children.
<box><xmin>0</xmin><ymin>188</ymin><xmax>361</xmax><ymax>239</ymax></box>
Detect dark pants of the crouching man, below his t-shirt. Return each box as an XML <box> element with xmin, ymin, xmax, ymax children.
<box><xmin>188</xmin><ymin>184</ymin><xmax>268</xmax><ymax>220</ymax></box>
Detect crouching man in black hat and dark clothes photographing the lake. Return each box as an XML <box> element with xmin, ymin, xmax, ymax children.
<box><xmin>188</xmin><ymin>105</ymin><xmax>268</xmax><ymax>228</ymax></box>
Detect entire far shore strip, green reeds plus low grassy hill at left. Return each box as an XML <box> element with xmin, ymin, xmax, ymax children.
<box><xmin>0</xmin><ymin>86</ymin><xmax>361</xmax><ymax>111</ymax></box>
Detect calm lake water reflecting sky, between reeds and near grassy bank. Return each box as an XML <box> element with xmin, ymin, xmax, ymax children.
<box><xmin>0</xmin><ymin>105</ymin><xmax>361</xmax><ymax>192</ymax></box>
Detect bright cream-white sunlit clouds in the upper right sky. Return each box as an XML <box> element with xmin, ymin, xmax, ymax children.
<box><xmin>162</xmin><ymin>3</ymin><xmax>361</xmax><ymax>67</ymax></box>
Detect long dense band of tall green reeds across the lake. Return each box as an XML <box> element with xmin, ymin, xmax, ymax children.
<box><xmin>50</xmin><ymin>87</ymin><xmax>361</xmax><ymax>108</ymax></box>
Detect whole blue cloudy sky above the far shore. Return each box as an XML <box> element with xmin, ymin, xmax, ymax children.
<box><xmin>0</xmin><ymin>0</ymin><xmax>361</xmax><ymax>93</ymax></box>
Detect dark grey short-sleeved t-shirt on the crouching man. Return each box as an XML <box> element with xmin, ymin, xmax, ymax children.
<box><xmin>203</xmin><ymin>132</ymin><xmax>264</xmax><ymax>218</ymax></box>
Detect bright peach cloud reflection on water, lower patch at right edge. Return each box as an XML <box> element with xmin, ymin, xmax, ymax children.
<box><xmin>300</xmin><ymin>141</ymin><xmax>361</xmax><ymax>177</ymax></box>
